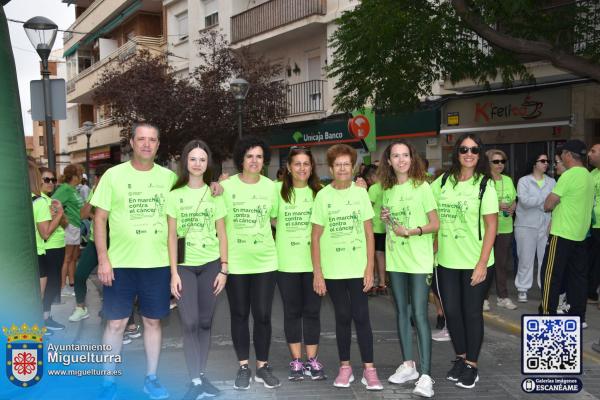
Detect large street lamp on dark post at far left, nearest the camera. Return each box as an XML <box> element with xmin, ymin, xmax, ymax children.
<box><xmin>23</xmin><ymin>17</ymin><xmax>58</xmax><ymax>172</ymax></box>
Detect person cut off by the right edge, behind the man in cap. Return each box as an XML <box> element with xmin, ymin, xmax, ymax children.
<box><xmin>588</xmin><ymin>143</ymin><xmax>600</xmax><ymax>304</ymax></box>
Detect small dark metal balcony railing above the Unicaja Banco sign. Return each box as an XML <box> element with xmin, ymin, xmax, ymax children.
<box><xmin>286</xmin><ymin>80</ymin><xmax>326</xmax><ymax>116</ymax></box>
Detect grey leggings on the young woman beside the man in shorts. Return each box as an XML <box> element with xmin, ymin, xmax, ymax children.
<box><xmin>177</xmin><ymin>259</ymin><xmax>221</xmax><ymax>379</ymax></box>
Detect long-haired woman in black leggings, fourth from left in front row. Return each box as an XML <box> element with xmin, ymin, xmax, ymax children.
<box><xmin>275</xmin><ymin>147</ymin><xmax>326</xmax><ymax>381</ymax></box>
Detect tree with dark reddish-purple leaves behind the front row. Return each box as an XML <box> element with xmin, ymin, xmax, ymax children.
<box><xmin>94</xmin><ymin>30</ymin><xmax>286</xmax><ymax>163</ymax></box>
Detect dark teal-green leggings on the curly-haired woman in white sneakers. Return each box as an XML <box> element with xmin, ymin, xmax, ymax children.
<box><xmin>389</xmin><ymin>272</ymin><xmax>431</xmax><ymax>375</ymax></box>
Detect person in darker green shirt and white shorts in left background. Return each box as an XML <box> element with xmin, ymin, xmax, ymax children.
<box><xmin>52</xmin><ymin>164</ymin><xmax>83</xmax><ymax>294</ymax></box>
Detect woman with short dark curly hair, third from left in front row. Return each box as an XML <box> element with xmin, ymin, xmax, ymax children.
<box><xmin>221</xmin><ymin>135</ymin><xmax>281</xmax><ymax>390</ymax></box>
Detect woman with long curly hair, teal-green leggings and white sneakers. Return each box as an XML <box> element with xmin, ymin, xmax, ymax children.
<box><xmin>379</xmin><ymin>141</ymin><xmax>440</xmax><ymax>397</ymax></box>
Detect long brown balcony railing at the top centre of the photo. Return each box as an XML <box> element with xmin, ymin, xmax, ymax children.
<box><xmin>231</xmin><ymin>0</ymin><xmax>327</xmax><ymax>43</ymax></box>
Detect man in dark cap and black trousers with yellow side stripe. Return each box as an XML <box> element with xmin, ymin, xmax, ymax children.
<box><xmin>540</xmin><ymin>140</ymin><xmax>594</xmax><ymax>324</ymax></box>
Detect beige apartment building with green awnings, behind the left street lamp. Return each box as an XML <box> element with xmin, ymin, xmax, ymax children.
<box><xmin>63</xmin><ymin>0</ymin><xmax>166</xmax><ymax>176</ymax></box>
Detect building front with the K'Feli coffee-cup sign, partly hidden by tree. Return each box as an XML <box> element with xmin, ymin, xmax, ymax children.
<box><xmin>440</xmin><ymin>0</ymin><xmax>600</xmax><ymax>178</ymax></box>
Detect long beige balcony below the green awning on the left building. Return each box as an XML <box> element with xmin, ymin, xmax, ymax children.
<box><xmin>67</xmin><ymin>36</ymin><xmax>165</xmax><ymax>103</ymax></box>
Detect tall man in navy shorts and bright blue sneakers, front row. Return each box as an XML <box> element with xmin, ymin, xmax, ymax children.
<box><xmin>91</xmin><ymin>123</ymin><xmax>177</xmax><ymax>399</ymax></box>
